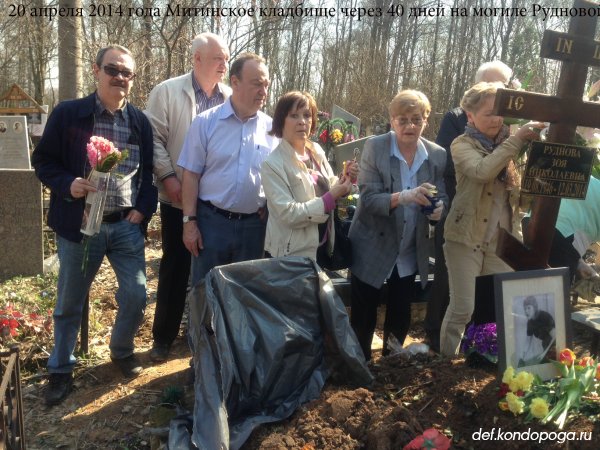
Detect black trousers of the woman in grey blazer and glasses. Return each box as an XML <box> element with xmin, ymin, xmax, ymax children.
<box><xmin>350</xmin><ymin>265</ymin><xmax>416</xmax><ymax>360</ymax></box>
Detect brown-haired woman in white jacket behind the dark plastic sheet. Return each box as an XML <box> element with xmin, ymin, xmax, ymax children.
<box><xmin>261</xmin><ymin>91</ymin><xmax>358</xmax><ymax>259</ymax></box>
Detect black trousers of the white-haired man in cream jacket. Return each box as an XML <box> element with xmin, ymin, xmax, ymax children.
<box><xmin>152</xmin><ymin>202</ymin><xmax>191</xmax><ymax>345</ymax></box>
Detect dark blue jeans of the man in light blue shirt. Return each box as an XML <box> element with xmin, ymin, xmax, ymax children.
<box><xmin>192</xmin><ymin>202</ymin><xmax>266</xmax><ymax>286</ymax></box>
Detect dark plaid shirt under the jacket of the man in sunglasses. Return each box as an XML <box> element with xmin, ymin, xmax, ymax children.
<box><xmin>94</xmin><ymin>94</ymin><xmax>140</xmax><ymax>215</ymax></box>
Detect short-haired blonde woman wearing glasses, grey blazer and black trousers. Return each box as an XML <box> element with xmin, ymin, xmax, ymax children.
<box><xmin>349</xmin><ymin>90</ymin><xmax>448</xmax><ymax>359</ymax></box>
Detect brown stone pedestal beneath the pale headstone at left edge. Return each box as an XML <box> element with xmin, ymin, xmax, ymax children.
<box><xmin>0</xmin><ymin>169</ymin><xmax>44</xmax><ymax>281</ymax></box>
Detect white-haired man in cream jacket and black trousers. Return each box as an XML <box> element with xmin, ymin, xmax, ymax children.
<box><xmin>145</xmin><ymin>33</ymin><xmax>231</xmax><ymax>362</ymax></box>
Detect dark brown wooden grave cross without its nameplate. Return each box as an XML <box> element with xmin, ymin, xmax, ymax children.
<box><xmin>494</xmin><ymin>0</ymin><xmax>600</xmax><ymax>270</ymax></box>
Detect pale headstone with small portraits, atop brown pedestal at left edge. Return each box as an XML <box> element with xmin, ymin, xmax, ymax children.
<box><xmin>0</xmin><ymin>116</ymin><xmax>31</xmax><ymax>169</ymax></box>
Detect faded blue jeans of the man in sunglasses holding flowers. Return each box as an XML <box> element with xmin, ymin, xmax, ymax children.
<box><xmin>48</xmin><ymin>220</ymin><xmax>146</xmax><ymax>373</ymax></box>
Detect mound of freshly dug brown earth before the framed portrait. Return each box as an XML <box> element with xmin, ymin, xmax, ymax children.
<box><xmin>243</xmin><ymin>355</ymin><xmax>600</xmax><ymax>450</ymax></box>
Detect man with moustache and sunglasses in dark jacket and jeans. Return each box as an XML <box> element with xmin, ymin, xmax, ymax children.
<box><xmin>32</xmin><ymin>45</ymin><xmax>158</xmax><ymax>406</ymax></box>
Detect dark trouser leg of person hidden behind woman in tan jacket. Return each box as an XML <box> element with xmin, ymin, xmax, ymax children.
<box><xmin>425</xmin><ymin>218</ymin><xmax>450</xmax><ymax>351</ymax></box>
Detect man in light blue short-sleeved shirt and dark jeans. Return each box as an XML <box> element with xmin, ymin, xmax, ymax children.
<box><xmin>178</xmin><ymin>53</ymin><xmax>278</xmax><ymax>286</ymax></box>
